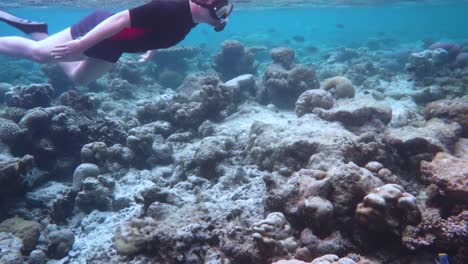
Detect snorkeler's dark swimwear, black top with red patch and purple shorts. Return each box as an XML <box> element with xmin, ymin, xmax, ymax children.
<box><xmin>71</xmin><ymin>0</ymin><xmax>196</xmax><ymax>62</ymax></box>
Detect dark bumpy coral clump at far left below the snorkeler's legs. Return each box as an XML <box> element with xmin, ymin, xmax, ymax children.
<box><xmin>5</xmin><ymin>84</ymin><xmax>54</xmax><ymax>109</ymax></box>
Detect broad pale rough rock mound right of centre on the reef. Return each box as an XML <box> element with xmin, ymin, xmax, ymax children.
<box><xmin>245</xmin><ymin>115</ymin><xmax>355</xmax><ymax>174</ymax></box>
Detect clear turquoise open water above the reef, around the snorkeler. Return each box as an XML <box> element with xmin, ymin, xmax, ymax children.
<box><xmin>0</xmin><ymin>1</ymin><xmax>468</xmax><ymax>51</ymax></box>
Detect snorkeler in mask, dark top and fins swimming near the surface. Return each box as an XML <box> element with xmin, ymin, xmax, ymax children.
<box><xmin>0</xmin><ymin>0</ymin><xmax>233</xmax><ymax>84</ymax></box>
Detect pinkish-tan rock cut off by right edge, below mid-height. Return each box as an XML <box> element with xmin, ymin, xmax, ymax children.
<box><xmin>421</xmin><ymin>152</ymin><xmax>468</xmax><ymax>203</ymax></box>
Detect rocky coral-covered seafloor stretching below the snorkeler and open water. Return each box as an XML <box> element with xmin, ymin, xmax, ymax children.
<box><xmin>0</xmin><ymin>37</ymin><xmax>468</xmax><ymax>264</ymax></box>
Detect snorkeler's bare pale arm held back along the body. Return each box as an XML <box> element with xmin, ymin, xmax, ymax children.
<box><xmin>50</xmin><ymin>10</ymin><xmax>131</xmax><ymax>59</ymax></box>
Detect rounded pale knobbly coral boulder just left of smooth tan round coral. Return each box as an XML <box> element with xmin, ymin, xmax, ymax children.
<box><xmin>296</xmin><ymin>89</ymin><xmax>333</xmax><ymax>117</ymax></box>
